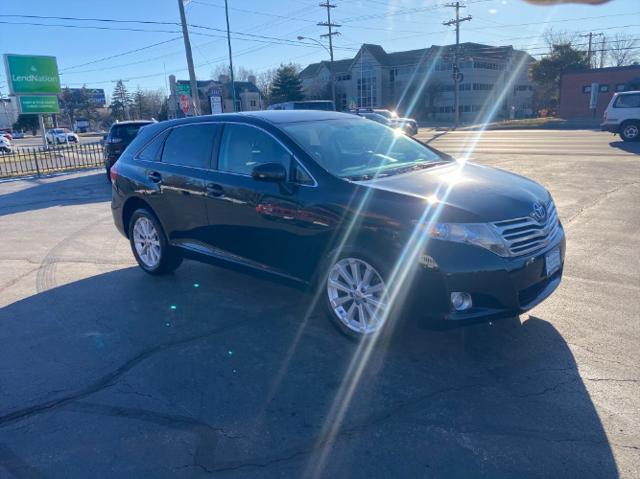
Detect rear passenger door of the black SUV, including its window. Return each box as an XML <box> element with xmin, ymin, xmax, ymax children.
<box><xmin>152</xmin><ymin>123</ymin><xmax>218</xmax><ymax>249</ymax></box>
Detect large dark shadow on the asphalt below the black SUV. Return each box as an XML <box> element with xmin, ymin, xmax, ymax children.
<box><xmin>0</xmin><ymin>261</ymin><xmax>618</xmax><ymax>478</ymax></box>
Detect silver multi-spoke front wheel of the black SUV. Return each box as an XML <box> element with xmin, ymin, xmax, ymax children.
<box><xmin>327</xmin><ymin>258</ymin><xmax>388</xmax><ymax>335</ymax></box>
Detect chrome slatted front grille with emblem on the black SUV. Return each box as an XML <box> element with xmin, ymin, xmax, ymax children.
<box><xmin>493</xmin><ymin>201</ymin><xmax>561</xmax><ymax>256</ymax></box>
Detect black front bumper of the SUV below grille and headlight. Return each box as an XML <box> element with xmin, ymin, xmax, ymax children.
<box><xmin>412</xmin><ymin>232</ymin><xmax>566</xmax><ymax>324</ymax></box>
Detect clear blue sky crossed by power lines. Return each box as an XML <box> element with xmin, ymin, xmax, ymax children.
<box><xmin>0</xmin><ymin>0</ymin><xmax>640</xmax><ymax>95</ymax></box>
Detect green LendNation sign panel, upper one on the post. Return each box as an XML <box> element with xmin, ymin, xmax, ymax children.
<box><xmin>4</xmin><ymin>54</ymin><xmax>60</xmax><ymax>95</ymax></box>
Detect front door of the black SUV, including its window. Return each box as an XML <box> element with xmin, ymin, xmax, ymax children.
<box><xmin>205</xmin><ymin>123</ymin><xmax>326</xmax><ymax>278</ymax></box>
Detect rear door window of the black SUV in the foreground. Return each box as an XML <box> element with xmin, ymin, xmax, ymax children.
<box><xmin>162</xmin><ymin>123</ymin><xmax>218</xmax><ymax>168</ymax></box>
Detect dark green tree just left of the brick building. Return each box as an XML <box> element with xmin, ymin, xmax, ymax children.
<box><xmin>531</xmin><ymin>43</ymin><xmax>589</xmax><ymax>108</ymax></box>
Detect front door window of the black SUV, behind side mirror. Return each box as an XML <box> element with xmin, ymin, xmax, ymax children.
<box><xmin>218</xmin><ymin>124</ymin><xmax>291</xmax><ymax>175</ymax></box>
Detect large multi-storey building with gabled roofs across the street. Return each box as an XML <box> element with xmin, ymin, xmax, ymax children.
<box><xmin>300</xmin><ymin>43</ymin><xmax>533</xmax><ymax>121</ymax></box>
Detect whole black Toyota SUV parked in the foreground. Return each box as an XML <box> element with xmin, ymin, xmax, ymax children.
<box><xmin>111</xmin><ymin>111</ymin><xmax>565</xmax><ymax>338</ymax></box>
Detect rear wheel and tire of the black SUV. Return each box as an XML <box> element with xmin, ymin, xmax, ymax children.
<box><xmin>129</xmin><ymin>208</ymin><xmax>182</xmax><ymax>275</ymax></box>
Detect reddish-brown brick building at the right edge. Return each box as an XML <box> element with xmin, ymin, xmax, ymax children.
<box><xmin>558</xmin><ymin>65</ymin><xmax>640</xmax><ymax>118</ymax></box>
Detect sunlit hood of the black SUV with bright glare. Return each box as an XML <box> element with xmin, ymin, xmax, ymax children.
<box><xmin>361</xmin><ymin>162</ymin><xmax>550</xmax><ymax>223</ymax></box>
